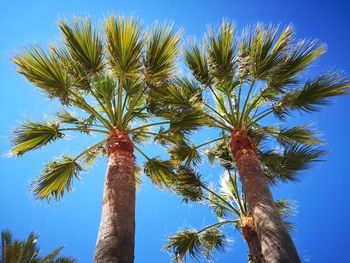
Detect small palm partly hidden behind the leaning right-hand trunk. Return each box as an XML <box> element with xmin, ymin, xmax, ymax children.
<box><xmin>164</xmin><ymin>167</ymin><xmax>292</xmax><ymax>263</ymax></box>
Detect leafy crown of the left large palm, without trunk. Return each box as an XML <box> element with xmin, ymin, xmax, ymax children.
<box><xmin>11</xmin><ymin>16</ymin><xmax>208</xmax><ymax>200</ymax></box>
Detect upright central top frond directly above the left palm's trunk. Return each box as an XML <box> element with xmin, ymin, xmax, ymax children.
<box><xmin>105</xmin><ymin>16</ymin><xmax>144</xmax><ymax>78</ymax></box>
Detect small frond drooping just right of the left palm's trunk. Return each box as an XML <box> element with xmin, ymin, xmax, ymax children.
<box><xmin>144</xmin><ymin>158</ymin><xmax>176</xmax><ymax>189</ymax></box>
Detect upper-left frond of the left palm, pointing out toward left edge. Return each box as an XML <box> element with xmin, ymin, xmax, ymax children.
<box><xmin>12</xmin><ymin>47</ymin><xmax>71</xmax><ymax>104</ymax></box>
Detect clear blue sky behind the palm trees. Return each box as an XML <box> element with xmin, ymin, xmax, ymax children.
<box><xmin>0</xmin><ymin>0</ymin><xmax>350</xmax><ymax>263</ymax></box>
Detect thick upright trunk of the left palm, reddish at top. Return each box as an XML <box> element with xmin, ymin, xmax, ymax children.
<box><xmin>94</xmin><ymin>130</ymin><xmax>135</xmax><ymax>263</ymax></box>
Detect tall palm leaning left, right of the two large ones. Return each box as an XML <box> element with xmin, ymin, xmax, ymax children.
<box><xmin>154</xmin><ymin>21</ymin><xmax>350</xmax><ymax>262</ymax></box>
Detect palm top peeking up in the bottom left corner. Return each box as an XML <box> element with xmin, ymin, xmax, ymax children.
<box><xmin>0</xmin><ymin>230</ymin><xmax>76</xmax><ymax>263</ymax></box>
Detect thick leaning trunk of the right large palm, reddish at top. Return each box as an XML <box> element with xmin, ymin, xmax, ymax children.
<box><xmin>230</xmin><ymin>130</ymin><xmax>300</xmax><ymax>263</ymax></box>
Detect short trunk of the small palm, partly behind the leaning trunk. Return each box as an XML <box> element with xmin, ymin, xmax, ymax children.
<box><xmin>241</xmin><ymin>216</ymin><xmax>266</xmax><ymax>263</ymax></box>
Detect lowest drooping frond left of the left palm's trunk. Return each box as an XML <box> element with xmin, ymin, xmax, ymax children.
<box><xmin>32</xmin><ymin>156</ymin><xmax>83</xmax><ymax>201</ymax></box>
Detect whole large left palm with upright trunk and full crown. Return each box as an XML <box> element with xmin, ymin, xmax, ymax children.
<box><xmin>12</xmin><ymin>16</ymin><xmax>200</xmax><ymax>263</ymax></box>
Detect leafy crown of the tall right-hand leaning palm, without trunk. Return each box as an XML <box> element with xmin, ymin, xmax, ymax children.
<box><xmin>149</xmin><ymin>21</ymin><xmax>350</xmax><ymax>186</ymax></box>
